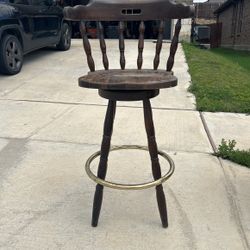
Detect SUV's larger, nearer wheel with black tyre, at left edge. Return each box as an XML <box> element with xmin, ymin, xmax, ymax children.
<box><xmin>0</xmin><ymin>35</ymin><xmax>23</xmax><ymax>75</ymax></box>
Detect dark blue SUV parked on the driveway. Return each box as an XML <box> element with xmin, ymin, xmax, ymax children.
<box><xmin>0</xmin><ymin>0</ymin><xmax>71</xmax><ymax>75</ymax></box>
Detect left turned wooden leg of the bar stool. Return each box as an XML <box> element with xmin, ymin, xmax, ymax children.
<box><xmin>92</xmin><ymin>100</ymin><xmax>116</xmax><ymax>227</ymax></box>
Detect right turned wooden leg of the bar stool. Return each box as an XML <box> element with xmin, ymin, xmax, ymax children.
<box><xmin>143</xmin><ymin>99</ymin><xmax>168</xmax><ymax>227</ymax></box>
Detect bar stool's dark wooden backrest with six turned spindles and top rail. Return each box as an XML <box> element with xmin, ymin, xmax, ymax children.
<box><xmin>64</xmin><ymin>0</ymin><xmax>194</xmax><ymax>71</ymax></box>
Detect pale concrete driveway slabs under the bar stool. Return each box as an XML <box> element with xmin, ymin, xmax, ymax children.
<box><xmin>0</xmin><ymin>40</ymin><xmax>250</xmax><ymax>250</ymax></box>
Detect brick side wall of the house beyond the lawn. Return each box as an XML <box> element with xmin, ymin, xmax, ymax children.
<box><xmin>218</xmin><ymin>0</ymin><xmax>250</xmax><ymax>50</ymax></box>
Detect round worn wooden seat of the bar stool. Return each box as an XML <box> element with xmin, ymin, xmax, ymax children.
<box><xmin>78</xmin><ymin>69</ymin><xmax>177</xmax><ymax>90</ymax></box>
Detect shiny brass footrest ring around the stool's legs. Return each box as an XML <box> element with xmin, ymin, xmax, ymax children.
<box><xmin>85</xmin><ymin>145</ymin><xmax>175</xmax><ymax>190</ymax></box>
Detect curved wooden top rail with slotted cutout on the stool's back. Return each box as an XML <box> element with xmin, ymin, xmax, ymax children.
<box><xmin>64</xmin><ymin>0</ymin><xmax>194</xmax><ymax>21</ymax></box>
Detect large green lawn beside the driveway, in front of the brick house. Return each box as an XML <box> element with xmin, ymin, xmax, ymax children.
<box><xmin>183</xmin><ymin>43</ymin><xmax>250</xmax><ymax>113</ymax></box>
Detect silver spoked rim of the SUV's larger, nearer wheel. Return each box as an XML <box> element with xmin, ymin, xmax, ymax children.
<box><xmin>6</xmin><ymin>40</ymin><xmax>22</xmax><ymax>71</ymax></box>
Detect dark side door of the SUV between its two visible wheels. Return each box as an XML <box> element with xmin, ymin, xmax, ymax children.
<box><xmin>29</xmin><ymin>0</ymin><xmax>62</xmax><ymax>47</ymax></box>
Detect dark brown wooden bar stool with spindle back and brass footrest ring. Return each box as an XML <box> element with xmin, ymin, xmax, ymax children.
<box><xmin>64</xmin><ymin>0</ymin><xmax>193</xmax><ymax>227</ymax></box>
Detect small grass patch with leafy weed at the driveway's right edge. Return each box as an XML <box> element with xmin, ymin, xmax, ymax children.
<box><xmin>215</xmin><ymin>139</ymin><xmax>250</xmax><ymax>168</ymax></box>
